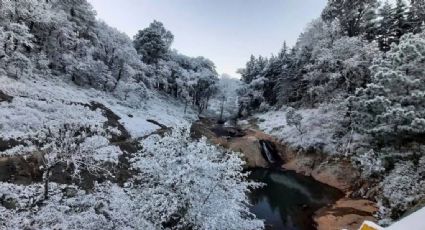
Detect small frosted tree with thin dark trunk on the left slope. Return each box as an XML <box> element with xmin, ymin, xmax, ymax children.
<box><xmin>35</xmin><ymin>124</ymin><xmax>121</xmax><ymax>200</ymax></box>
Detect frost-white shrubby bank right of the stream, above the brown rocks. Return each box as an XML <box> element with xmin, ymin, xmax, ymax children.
<box><xmin>257</xmin><ymin>103</ymin><xmax>348</xmax><ymax>154</ymax></box>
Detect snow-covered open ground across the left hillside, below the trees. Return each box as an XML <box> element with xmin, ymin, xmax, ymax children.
<box><xmin>0</xmin><ymin>76</ymin><xmax>196</xmax><ymax>155</ymax></box>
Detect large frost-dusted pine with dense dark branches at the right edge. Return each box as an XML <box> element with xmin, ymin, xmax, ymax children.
<box><xmin>351</xmin><ymin>31</ymin><xmax>425</xmax><ymax>143</ymax></box>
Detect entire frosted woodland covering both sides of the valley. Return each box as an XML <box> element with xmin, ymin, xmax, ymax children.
<box><xmin>0</xmin><ymin>0</ymin><xmax>425</xmax><ymax>229</ymax></box>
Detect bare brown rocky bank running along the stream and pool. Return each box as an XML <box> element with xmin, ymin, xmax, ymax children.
<box><xmin>191</xmin><ymin>119</ymin><xmax>377</xmax><ymax>230</ymax></box>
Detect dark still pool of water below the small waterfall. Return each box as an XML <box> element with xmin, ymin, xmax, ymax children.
<box><xmin>250</xmin><ymin>169</ymin><xmax>342</xmax><ymax>230</ymax></box>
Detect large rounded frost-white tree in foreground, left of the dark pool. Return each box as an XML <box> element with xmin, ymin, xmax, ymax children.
<box><xmin>133</xmin><ymin>129</ymin><xmax>263</xmax><ymax>229</ymax></box>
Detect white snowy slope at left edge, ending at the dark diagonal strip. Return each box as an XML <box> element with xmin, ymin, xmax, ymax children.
<box><xmin>0</xmin><ymin>76</ymin><xmax>106</xmax><ymax>140</ymax></box>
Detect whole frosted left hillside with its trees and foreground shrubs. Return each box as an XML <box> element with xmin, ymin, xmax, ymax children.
<box><xmin>0</xmin><ymin>0</ymin><xmax>263</xmax><ymax>230</ymax></box>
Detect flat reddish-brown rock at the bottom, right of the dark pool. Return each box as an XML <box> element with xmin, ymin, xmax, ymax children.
<box><xmin>314</xmin><ymin>198</ymin><xmax>378</xmax><ymax>230</ymax></box>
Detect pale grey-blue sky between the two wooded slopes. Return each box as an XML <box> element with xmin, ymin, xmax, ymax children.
<box><xmin>89</xmin><ymin>0</ymin><xmax>326</xmax><ymax>77</ymax></box>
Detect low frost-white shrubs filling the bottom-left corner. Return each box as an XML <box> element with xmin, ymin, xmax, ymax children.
<box><xmin>0</xmin><ymin>183</ymin><xmax>157</xmax><ymax>230</ymax></box>
